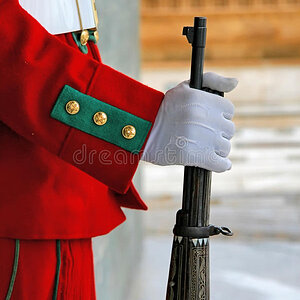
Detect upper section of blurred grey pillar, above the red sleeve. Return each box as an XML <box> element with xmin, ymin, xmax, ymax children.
<box><xmin>96</xmin><ymin>0</ymin><xmax>140</xmax><ymax>77</ymax></box>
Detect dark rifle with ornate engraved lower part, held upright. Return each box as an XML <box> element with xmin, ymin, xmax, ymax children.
<box><xmin>166</xmin><ymin>17</ymin><xmax>233</xmax><ymax>300</ymax></box>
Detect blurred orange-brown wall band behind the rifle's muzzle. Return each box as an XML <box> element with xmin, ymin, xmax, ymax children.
<box><xmin>141</xmin><ymin>0</ymin><xmax>300</xmax><ymax>63</ymax></box>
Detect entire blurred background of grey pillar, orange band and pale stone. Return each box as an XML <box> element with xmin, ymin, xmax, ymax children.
<box><xmin>94</xmin><ymin>0</ymin><xmax>300</xmax><ymax>300</ymax></box>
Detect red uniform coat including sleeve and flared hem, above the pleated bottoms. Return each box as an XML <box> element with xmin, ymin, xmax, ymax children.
<box><xmin>0</xmin><ymin>0</ymin><xmax>163</xmax><ymax>239</ymax></box>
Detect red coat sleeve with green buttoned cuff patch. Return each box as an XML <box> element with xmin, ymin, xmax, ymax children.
<box><xmin>0</xmin><ymin>0</ymin><xmax>163</xmax><ymax>193</ymax></box>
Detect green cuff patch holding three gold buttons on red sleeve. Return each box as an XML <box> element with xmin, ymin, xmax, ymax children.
<box><xmin>51</xmin><ymin>85</ymin><xmax>152</xmax><ymax>153</ymax></box>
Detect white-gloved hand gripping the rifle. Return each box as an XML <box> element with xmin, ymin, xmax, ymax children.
<box><xmin>141</xmin><ymin>73</ymin><xmax>238</xmax><ymax>172</ymax></box>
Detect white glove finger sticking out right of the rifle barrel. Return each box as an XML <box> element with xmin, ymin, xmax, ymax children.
<box><xmin>203</xmin><ymin>72</ymin><xmax>238</xmax><ymax>93</ymax></box>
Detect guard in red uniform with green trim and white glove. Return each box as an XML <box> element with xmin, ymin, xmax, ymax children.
<box><xmin>0</xmin><ymin>0</ymin><xmax>237</xmax><ymax>300</ymax></box>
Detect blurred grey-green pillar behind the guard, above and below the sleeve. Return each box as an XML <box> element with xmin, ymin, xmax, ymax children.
<box><xmin>93</xmin><ymin>0</ymin><xmax>142</xmax><ymax>300</ymax></box>
